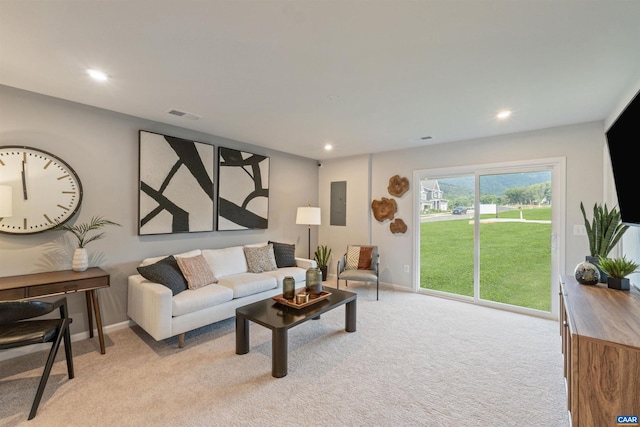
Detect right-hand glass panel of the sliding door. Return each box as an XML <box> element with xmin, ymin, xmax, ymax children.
<box><xmin>477</xmin><ymin>170</ymin><xmax>552</xmax><ymax>312</ymax></box>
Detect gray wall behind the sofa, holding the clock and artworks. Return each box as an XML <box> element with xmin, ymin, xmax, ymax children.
<box><xmin>0</xmin><ymin>86</ymin><xmax>318</xmax><ymax>333</ymax></box>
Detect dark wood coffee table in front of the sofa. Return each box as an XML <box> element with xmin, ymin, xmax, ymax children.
<box><xmin>236</xmin><ymin>288</ymin><xmax>357</xmax><ymax>378</ymax></box>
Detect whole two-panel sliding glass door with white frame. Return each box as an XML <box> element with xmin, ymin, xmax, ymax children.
<box><xmin>416</xmin><ymin>162</ymin><xmax>563</xmax><ymax>313</ymax></box>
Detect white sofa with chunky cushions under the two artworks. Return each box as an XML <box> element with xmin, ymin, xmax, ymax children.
<box><xmin>127</xmin><ymin>242</ymin><xmax>317</xmax><ymax>347</ymax></box>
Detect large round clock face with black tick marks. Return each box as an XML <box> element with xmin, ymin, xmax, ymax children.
<box><xmin>0</xmin><ymin>145</ymin><xmax>82</xmax><ymax>234</ymax></box>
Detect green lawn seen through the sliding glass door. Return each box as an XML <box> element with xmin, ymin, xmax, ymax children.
<box><xmin>420</xmin><ymin>207</ymin><xmax>551</xmax><ymax>311</ymax></box>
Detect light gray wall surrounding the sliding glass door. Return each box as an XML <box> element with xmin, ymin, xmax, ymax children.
<box><xmin>319</xmin><ymin>121</ymin><xmax>608</xmax><ymax>289</ymax></box>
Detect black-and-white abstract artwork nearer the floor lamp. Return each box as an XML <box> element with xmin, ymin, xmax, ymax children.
<box><xmin>218</xmin><ymin>147</ymin><xmax>269</xmax><ymax>231</ymax></box>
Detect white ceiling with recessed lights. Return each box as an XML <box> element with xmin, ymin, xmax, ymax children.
<box><xmin>0</xmin><ymin>0</ymin><xmax>640</xmax><ymax>159</ymax></box>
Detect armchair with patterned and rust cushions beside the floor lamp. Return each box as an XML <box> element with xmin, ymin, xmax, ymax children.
<box><xmin>336</xmin><ymin>245</ymin><xmax>380</xmax><ymax>300</ymax></box>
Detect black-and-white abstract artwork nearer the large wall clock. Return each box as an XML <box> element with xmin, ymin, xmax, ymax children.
<box><xmin>138</xmin><ymin>131</ymin><xmax>215</xmax><ymax>235</ymax></box>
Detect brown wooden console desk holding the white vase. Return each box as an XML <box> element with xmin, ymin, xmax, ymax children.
<box><xmin>0</xmin><ymin>267</ymin><xmax>109</xmax><ymax>354</ymax></box>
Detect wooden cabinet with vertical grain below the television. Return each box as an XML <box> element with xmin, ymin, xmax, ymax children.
<box><xmin>560</xmin><ymin>276</ymin><xmax>640</xmax><ymax>427</ymax></box>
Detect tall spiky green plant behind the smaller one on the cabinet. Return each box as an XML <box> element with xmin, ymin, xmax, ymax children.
<box><xmin>580</xmin><ymin>202</ymin><xmax>629</xmax><ymax>258</ymax></box>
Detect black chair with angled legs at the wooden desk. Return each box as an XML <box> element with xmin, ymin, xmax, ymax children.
<box><xmin>0</xmin><ymin>297</ymin><xmax>73</xmax><ymax>420</ymax></box>
